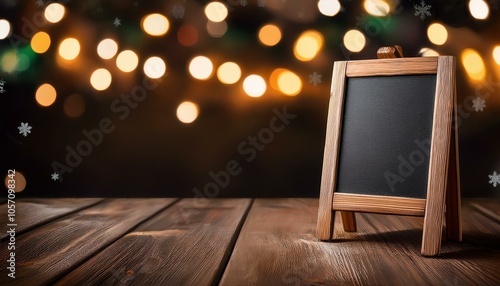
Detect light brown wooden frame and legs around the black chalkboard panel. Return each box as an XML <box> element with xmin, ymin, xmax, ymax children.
<box><xmin>316</xmin><ymin>56</ymin><xmax>462</xmax><ymax>256</ymax></box>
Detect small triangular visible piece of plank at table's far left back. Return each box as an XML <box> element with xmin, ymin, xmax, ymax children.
<box><xmin>0</xmin><ymin>198</ymin><xmax>103</xmax><ymax>241</ymax></box>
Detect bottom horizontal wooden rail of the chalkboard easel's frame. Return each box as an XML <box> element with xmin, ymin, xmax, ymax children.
<box><xmin>333</xmin><ymin>193</ymin><xmax>425</xmax><ymax>216</ymax></box>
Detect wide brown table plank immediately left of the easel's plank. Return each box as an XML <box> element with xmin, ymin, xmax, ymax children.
<box><xmin>56</xmin><ymin>199</ymin><xmax>251</xmax><ymax>285</ymax></box>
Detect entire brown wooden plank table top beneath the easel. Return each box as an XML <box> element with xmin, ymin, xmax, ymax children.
<box><xmin>0</xmin><ymin>198</ymin><xmax>500</xmax><ymax>286</ymax></box>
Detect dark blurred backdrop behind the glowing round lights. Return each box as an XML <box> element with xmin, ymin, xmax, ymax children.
<box><xmin>0</xmin><ymin>0</ymin><xmax>500</xmax><ymax>197</ymax></box>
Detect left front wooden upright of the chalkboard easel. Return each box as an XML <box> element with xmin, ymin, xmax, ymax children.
<box><xmin>316</xmin><ymin>61</ymin><xmax>347</xmax><ymax>240</ymax></box>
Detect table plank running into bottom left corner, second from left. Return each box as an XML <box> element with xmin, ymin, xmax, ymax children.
<box><xmin>0</xmin><ymin>199</ymin><xmax>175</xmax><ymax>285</ymax></box>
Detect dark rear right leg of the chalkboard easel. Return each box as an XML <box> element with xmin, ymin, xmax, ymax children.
<box><xmin>446</xmin><ymin>97</ymin><xmax>462</xmax><ymax>241</ymax></box>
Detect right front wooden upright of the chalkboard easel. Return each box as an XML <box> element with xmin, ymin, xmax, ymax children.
<box><xmin>421</xmin><ymin>56</ymin><xmax>455</xmax><ymax>256</ymax></box>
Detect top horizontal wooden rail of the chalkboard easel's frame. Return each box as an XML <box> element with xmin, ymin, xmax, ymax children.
<box><xmin>346</xmin><ymin>57</ymin><xmax>438</xmax><ymax>77</ymax></box>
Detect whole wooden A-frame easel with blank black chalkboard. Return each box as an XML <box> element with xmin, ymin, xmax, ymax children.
<box><xmin>316</xmin><ymin>50</ymin><xmax>462</xmax><ymax>256</ymax></box>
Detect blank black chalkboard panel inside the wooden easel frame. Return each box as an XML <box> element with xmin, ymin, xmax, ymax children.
<box><xmin>335</xmin><ymin>74</ymin><xmax>436</xmax><ymax>199</ymax></box>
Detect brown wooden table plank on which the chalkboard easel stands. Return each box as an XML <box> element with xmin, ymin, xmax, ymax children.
<box><xmin>220</xmin><ymin>199</ymin><xmax>500</xmax><ymax>286</ymax></box>
